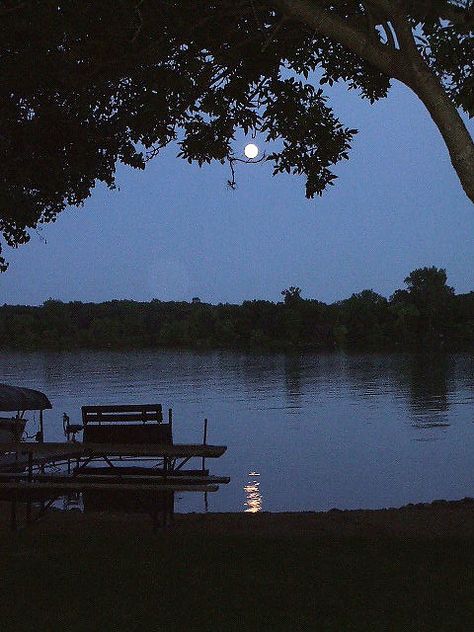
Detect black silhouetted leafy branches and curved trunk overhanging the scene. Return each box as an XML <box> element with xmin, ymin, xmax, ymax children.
<box><xmin>0</xmin><ymin>0</ymin><xmax>474</xmax><ymax>268</ymax></box>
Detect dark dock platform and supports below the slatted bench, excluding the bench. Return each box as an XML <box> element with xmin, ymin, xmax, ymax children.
<box><xmin>0</xmin><ymin>442</ymin><xmax>230</xmax><ymax>529</ymax></box>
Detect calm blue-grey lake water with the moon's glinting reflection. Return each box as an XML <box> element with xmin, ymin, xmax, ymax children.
<box><xmin>0</xmin><ymin>351</ymin><xmax>474</xmax><ymax>511</ymax></box>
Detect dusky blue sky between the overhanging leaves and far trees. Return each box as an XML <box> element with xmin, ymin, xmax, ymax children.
<box><xmin>0</xmin><ymin>78</ymin><xmax>474</xmax><ymax>305</ymax></box>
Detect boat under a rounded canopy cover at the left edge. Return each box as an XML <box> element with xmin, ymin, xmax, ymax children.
<box><xmin>0</xmin><ymin>384</ymin><xmax>52</xmax><ymax>443</ymax></box>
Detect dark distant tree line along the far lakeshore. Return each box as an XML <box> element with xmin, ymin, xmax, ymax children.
<box><xmin>0</xmin><ymin>267</ymin><xmax>474</xmax><ymax>351</ymax></box>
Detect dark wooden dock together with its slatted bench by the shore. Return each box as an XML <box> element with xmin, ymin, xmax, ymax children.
<box><xmin>0</xmin><ymin>404</ymin><xmax>230</xmax><ymax>529</ymax></box>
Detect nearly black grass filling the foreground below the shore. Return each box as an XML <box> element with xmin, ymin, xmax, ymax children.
<box><xmin>0</xmin><ymin>523</ymin><xmax>474</xmax><ymax>632</ymax></box>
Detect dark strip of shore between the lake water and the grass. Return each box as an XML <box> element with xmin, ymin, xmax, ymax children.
<box><xmin>0</xmin><ymin>497</ymin><xmax>474</xmax><ymax>540</ymax></box>
